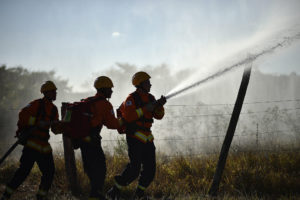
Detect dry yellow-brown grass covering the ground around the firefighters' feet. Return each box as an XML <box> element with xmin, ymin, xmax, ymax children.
<box><xmin>0</xmin><ymin>152</ymin><xmax>300</xmax><ymax>200</ymax></box>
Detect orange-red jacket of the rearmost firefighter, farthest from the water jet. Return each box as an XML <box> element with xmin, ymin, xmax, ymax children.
<box><xmin>17</xmin><ymin>98</ymin><xmax>58</xmax><ymax>153</ymax></box>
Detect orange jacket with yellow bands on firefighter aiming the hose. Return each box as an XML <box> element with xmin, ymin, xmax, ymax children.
<box><xmin>120</xmin><ymin>91</ymin><xmax>164</xmax><ymax>143</ymax></box>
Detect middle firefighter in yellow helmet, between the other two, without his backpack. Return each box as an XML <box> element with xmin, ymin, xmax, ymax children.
<box><xmin>79</xmin><ymin>76</ymin><xmax>123</xmax><ymax>200</ymax></box>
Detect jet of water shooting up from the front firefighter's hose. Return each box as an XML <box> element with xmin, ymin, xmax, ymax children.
<box><xmin>166</xmin><ymin>33</ymin><xmax>300</xmax><ymax>99</ymax></box>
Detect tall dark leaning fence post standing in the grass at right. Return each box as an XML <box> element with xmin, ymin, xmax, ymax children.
<box><xmin>209</xmin><ymin>66</ymin><xmax>251</xmax><ymax>196</ymax></box>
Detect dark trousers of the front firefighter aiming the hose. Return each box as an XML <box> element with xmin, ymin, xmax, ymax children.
<box><xmin>115</xmin><ymin>137</ymin><xmax>156</xmax><ymax>188</ymax></box>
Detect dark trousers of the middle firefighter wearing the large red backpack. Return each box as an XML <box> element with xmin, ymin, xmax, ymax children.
<box><xmin>80</xmin><ymin>141</ymin><xmax>106</xmax><ymax>197</ymax></box>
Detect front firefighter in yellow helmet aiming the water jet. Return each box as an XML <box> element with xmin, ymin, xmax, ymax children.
<box><xmin>107</xmin><ymin>71</ymin><xmax>166</xmax><ymax>199</ymax></box>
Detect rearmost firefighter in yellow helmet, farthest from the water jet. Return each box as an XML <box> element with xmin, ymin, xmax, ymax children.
<box><xmin>1</xmin><ymin>81</ymin><xmax>62</xmax><ymax>200</ymax></box>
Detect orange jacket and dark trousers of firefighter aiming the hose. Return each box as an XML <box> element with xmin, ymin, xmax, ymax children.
<box><xmin>115</xmin><ymin>91</ymin><xmax>164</xmax><ymax>190</ymax></box>
